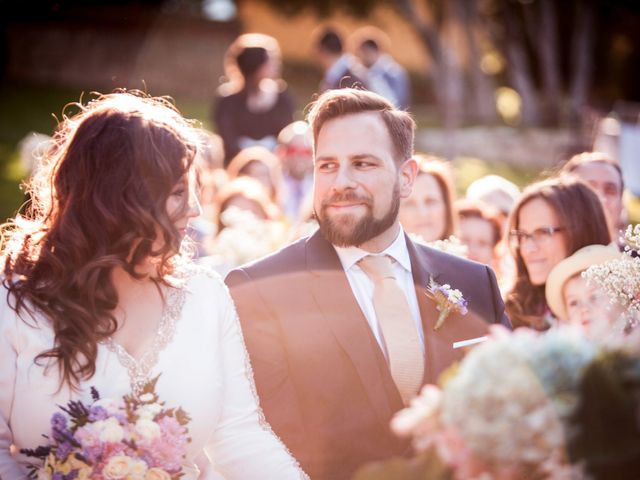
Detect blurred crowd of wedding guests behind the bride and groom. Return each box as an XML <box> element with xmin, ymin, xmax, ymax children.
<box><xmin>17</xmin><ymin>27</ymin><xmax>635</xmax><ymax>340</ymax></box>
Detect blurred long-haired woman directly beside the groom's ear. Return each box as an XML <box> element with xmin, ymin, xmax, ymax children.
<box><xmin>400</xmin><ymin>155</ymin><xmax>456</xmax><ymax>242</ymax></box>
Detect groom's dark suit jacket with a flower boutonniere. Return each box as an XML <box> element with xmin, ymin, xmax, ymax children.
<box><xmin>226</xmin><ymin>232</ymin><xmax>509</xmax><ymax>479</ymax></box>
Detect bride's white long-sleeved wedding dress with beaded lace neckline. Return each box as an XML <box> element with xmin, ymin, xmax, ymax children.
<box><xmin>0</xmin><ymin>269</ymin><xmax>307</xmax><ymax>480</ymax></box>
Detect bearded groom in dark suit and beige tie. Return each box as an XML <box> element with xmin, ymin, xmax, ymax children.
<box><xmin>226</xmin><ymin>89</ymin><xmax>509</xmax><ymax>480</ymax></box>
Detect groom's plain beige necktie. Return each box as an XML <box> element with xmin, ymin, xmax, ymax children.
<box><xmin>359</xmin><ymin>255</ymin><xmax>424</xmax><ymax>404</ymax></box>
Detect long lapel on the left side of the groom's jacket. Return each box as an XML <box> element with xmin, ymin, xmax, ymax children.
<box><xmin>307</xmin><ymin>231</ymin><xmax>402</xmax><ymax>427</ymax></box>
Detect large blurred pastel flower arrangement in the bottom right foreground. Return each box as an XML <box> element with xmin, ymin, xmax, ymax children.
<box><xmin>355</xmin><ymin>326</ymin><xmax>640</xmax><ymax>480</ymax></box>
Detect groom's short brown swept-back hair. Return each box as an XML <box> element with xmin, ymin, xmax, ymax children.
<box><xmin>307</xmin><ymin>88</ymin><xmax>416</xmax><ymax>164</ymax></box>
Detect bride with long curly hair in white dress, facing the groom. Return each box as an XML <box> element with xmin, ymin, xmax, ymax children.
<box><xmin>0</xmin><ymin>93</ymin><xmax>306</xmax><ymax>480</ymax></box>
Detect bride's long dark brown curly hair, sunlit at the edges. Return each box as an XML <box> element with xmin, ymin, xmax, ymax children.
<box><xmin>2</xmin><ymin>92</ymin><xmax>197</xmax><ymax>387</ymax></box>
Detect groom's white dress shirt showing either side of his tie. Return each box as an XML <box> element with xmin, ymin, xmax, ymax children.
<box><xmin>334</xmin><ymin>227</ymin><xmax>424</xmax><ymax>355</ymax></box>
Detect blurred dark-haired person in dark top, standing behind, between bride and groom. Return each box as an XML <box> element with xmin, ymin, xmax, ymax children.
<box><xmin>213</xmin><ymin>33</ymin><xmax>294</xmax><ymax>165</ymax></box>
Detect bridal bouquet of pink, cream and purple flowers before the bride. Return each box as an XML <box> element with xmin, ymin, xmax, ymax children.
<box><xmin>21</xmin><ymin>377</ymin><xmax>191</xmax><ymax>480</ymax></box>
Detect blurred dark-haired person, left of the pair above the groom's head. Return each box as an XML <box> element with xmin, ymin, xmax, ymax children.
<box><xmin>314</xmin><ymin>27</ymin><xmax>365</xmax><ymax>92</ymax></box>
